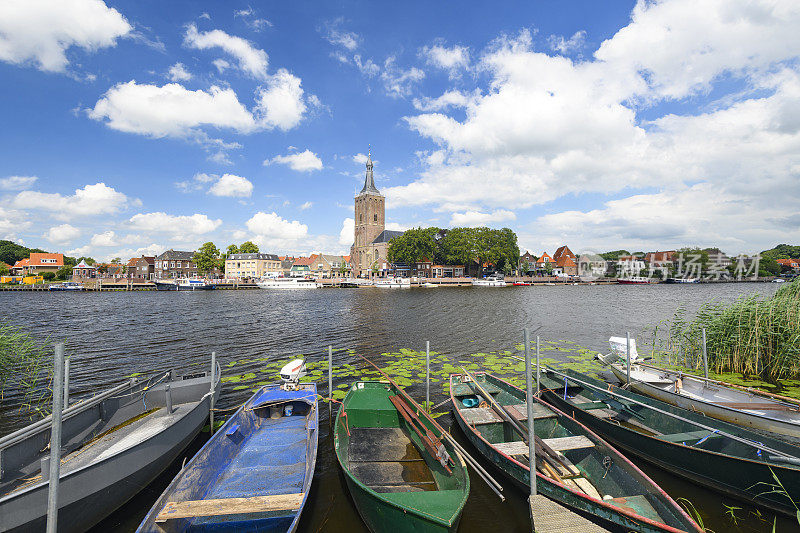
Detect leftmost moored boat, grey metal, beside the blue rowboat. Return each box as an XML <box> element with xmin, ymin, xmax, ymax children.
<box><xmin>0</xmin><ymin>371</ymin><xmax>220</xmax><ymax>532</ymax></box>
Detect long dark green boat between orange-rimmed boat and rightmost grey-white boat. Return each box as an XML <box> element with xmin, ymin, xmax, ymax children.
<box><xmin>541</xmin><ymin>369</ymin><xmax>800</xmax><ymax>517</ymax></box>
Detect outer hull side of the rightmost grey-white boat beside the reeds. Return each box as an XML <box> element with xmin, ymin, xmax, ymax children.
<box><xmin>611</xmin><ymin>365</ymin><xmax>800</xmax><ymax>444</ymax></box>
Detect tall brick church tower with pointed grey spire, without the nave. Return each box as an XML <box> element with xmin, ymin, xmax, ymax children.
<box><xmin>350</xmin><ymin>148</ymin><xmax>386</xmax><ymax>274</ymax></box>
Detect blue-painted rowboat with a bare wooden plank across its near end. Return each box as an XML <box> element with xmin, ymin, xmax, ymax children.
<box><xmin>137</xmin><ymin>383</ymin><xmax>319</xmax><ymax>533</ymax></box>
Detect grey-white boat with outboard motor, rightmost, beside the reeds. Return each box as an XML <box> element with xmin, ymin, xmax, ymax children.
<box><xmin>611</xmin><ymin>362</ymin><xmax>800</xmax><ymax>444</ymax></box>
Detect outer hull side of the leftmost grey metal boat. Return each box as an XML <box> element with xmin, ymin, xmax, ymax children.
<box><xmin>0</xmin><ymin>374</ymin><xmax>219</xmax><ymax>533</ymax></box>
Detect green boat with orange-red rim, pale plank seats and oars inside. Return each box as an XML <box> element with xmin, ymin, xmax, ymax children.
<box><xmin>450</xmin><ymin>373</ymin><xmax>703</xmax><ymax>533</ymax></box>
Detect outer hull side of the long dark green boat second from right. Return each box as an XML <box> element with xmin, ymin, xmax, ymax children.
<box><xmin>543</xmin><ymin>370</ymin><xmax>800</xmax><ymax>516</ymax></box>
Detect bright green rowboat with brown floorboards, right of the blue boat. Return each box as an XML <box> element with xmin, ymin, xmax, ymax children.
<box><xmin>333</xmin><ymin>381</ymin><xmax>469</xmax><ymax>532</ymax></box>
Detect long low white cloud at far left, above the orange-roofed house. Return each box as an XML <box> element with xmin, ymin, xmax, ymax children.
<box><xmin>12</xmin><ymin>183</ymin><xmax>130</xmax><ymax>218</ymax></box>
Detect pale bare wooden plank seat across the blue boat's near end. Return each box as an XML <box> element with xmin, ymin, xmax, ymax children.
<box><xmin>156</xmin><ymin>492</ymin><xmax>305</xmax><ymax>522</ymax></box>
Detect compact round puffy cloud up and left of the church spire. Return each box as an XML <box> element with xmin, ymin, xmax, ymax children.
<box><xmin>256</xmin><ymin>69</ymin><xmax>307</xmax><ymax>131</ymax></box>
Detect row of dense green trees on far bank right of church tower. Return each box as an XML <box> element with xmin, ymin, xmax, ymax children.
<box><xmin>388</xmin><ymin>227</ymin><xmax>519</xmax><ymax>273</ymax></box>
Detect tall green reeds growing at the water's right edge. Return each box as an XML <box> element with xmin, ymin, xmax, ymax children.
<box><xmin>653</xmin><ymin>278</ymin><xmax>800</xmax><ymax>383</ymax></box>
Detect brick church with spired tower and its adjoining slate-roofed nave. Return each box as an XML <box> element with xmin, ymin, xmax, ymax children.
<box><xmin>350</xmin><ymin>150</ymin><xmax>403</xmax><ymax>277</ymax></box>
